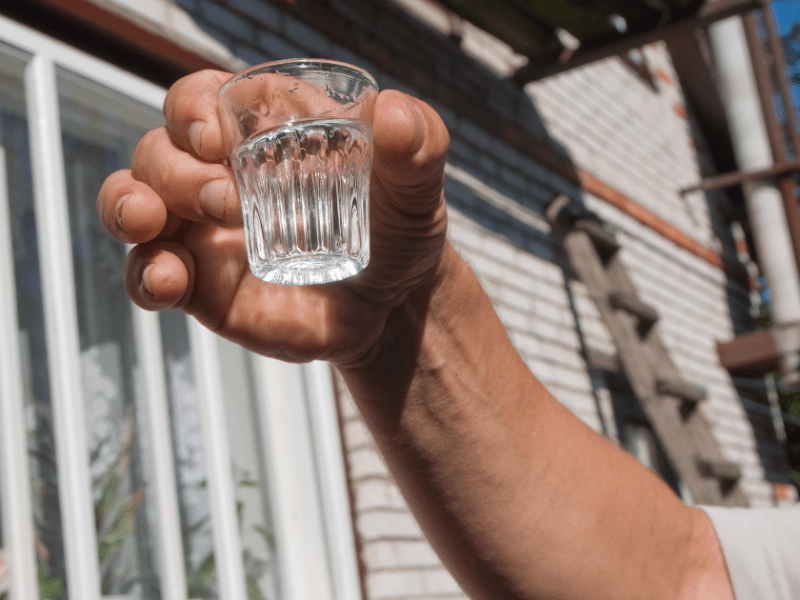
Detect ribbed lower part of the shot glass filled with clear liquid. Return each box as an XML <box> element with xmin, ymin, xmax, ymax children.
<box><xmin>233</xmin><ymin>119</ymin><xmax>372</xmax><ymax>285</ymax></box>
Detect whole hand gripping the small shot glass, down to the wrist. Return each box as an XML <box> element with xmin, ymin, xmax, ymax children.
<box><xmin>98</xmin><ymin>71</ymin><xmax>451</xmax><ymax>365</ymax></box>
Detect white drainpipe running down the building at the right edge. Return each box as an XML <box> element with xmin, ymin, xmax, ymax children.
<box><xmin>708</xmin><ymin>17</ymin><xmax>800</xmax><ymax>383</ymax></box>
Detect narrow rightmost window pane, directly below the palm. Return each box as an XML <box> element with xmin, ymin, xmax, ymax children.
<box><xmin>218</xmin><ymin>338</ymin><xmax>279</xmax><ymax>600</ymax></box>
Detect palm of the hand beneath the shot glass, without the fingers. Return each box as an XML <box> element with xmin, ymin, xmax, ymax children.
<box><xmin>173</xmin><ymin>162</ymin><xmax>446</xmax><ymax>362</ymax></box>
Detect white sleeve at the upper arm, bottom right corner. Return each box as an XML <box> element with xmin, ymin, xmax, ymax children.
<box><xmin>699</xmin><ymin>506</ymin><xmax>800</xmax><ymax>600</ymax></box>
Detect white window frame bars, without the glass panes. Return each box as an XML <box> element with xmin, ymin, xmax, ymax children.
<box><xmin>0</xmin><ymin>16</ymin><xmax>361</xmax><ymax>600</ymax></box>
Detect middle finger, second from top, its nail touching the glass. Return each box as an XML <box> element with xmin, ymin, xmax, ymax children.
<box><xmin>131</xmin><ymin>128</ymin><xmax>242</xmax><ymax>226</ymax></box>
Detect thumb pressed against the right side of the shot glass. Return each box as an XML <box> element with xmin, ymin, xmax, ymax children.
<box><xmin>372</xmin><ymin>90</ymin><xmax>450</xmax><ymax>215</ymax></box>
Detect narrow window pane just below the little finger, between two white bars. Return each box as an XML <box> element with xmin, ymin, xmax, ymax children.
<box><xmin>160</xmin><ymin>311</ymin><xmax>219</xmax><ymax>598</ymax></box>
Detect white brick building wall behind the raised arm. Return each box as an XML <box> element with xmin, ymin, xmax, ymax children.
<box><xmin>54</xmin><ymin>0</ymin><xmax>792</xmax><ymax>600</ymax></box>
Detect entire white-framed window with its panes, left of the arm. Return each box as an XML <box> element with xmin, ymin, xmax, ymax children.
<box><xmin>0</xmin><ymin>17</ymin><xmax>360</xmax><ymax>600</ymax></box>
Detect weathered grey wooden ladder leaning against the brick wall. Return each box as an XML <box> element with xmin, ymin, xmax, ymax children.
<box><xmin>552</xmin><ymin>199</ymin><xmax>748</xmax><ymax>506</ymax></box>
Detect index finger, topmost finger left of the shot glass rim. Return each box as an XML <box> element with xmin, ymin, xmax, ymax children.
<box><xmin>164</xmin><ymin>70</ymin><xmax>231</xmax><ymax>162</ymax></box>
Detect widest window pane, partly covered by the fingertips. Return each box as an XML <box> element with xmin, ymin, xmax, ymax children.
<box><xmin>57</xmin><ymin>69</ymin><xmax>162</xmax><ymax>599</ymax></box>
